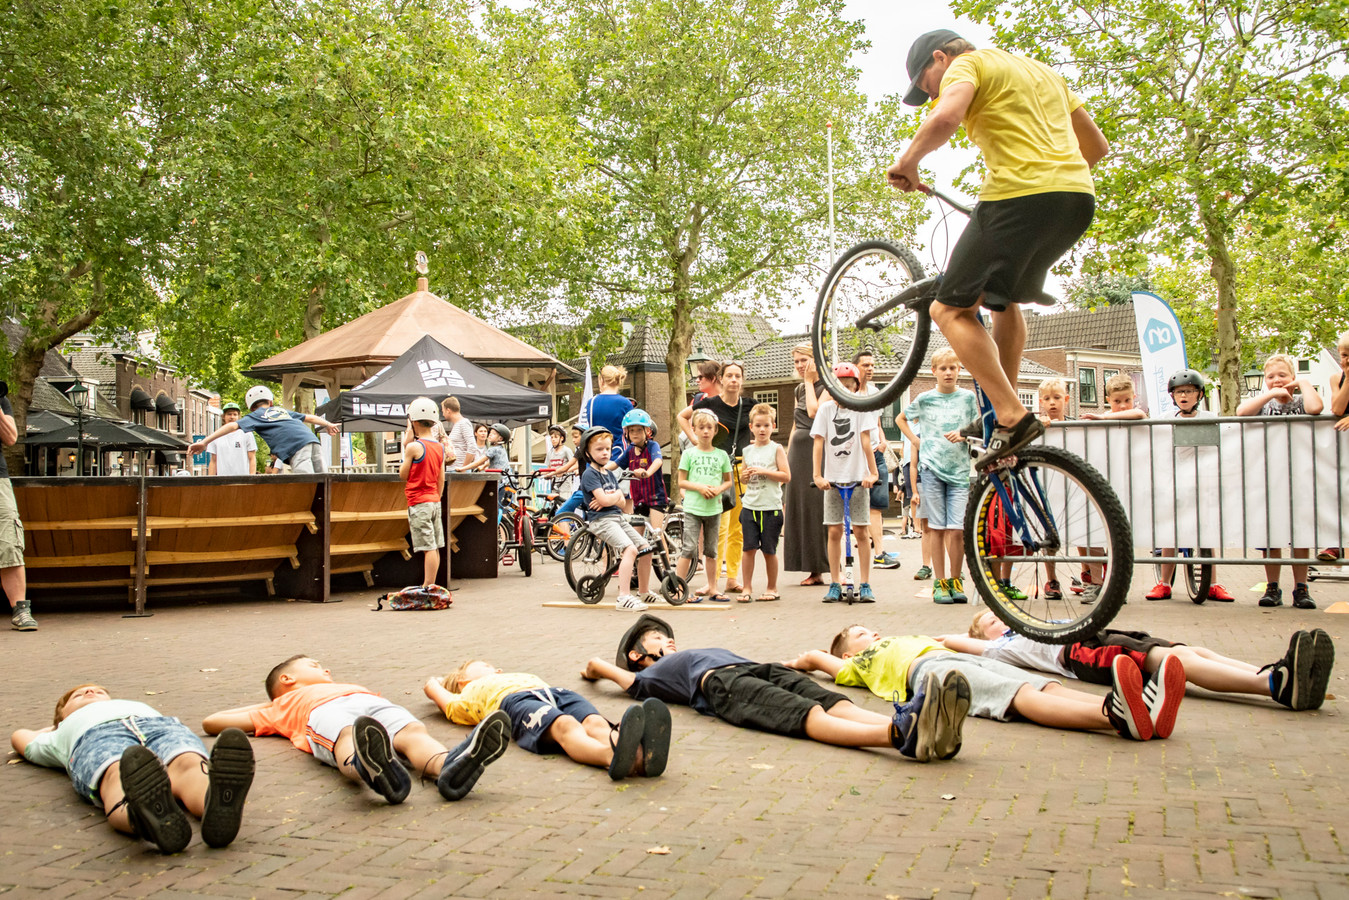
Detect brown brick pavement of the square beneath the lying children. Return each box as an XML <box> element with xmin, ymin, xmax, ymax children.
<box><xmin>0</xmin><ymin>531</ymin><xmax>1349</xmax><ymax>899</ymax></box>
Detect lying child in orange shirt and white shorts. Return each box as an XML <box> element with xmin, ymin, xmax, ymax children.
<box><xmin>202</xmin><ymin>654</ymin><xmax>510</xmax><ymax>803</ymax></box>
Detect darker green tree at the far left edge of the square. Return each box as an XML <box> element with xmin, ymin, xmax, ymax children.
<box><xmin>0</xmin><ymin>0</ymin><xmax>200</xmax><ymax>471</ymax></box>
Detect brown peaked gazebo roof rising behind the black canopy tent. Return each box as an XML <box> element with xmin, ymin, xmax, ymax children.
<box><xmin>244</xmin><ymin>278</ymin><xmax>580</xmax><ymax>386</ymax></box>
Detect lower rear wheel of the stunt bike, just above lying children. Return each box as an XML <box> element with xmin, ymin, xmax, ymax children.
<box><xmin>965</xmin><ymin>445</ymin><xmax>1133</xmax><ymax>644</ymax></box>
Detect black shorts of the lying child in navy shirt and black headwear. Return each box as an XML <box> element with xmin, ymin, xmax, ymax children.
<box><xmin>703</xmin><ymin>663</ymin><xmax>847</xmax><ymax>738</ymax></box>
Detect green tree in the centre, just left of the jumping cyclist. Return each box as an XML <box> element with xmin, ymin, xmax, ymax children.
<box><xmin>540</xmin><ymin>0</ymin><xmax>916</xmax><ymax>450</ymax></box>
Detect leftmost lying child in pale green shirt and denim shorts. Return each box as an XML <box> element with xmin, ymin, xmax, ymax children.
<box><xmin>9</xmin><ymin>684</ymin><xmax>254</xmax><ymax>853</ymax></box>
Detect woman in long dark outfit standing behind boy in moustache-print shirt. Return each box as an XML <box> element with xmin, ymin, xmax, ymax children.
<box><xmin>782</xmin><ymin>341</ymin><xmax>830</xmax><ymax>587</ymax></box>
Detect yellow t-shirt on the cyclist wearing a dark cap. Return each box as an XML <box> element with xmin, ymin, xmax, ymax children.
<box><xmin>940</xmin><ymin>50</ymin><xmax>1095</xmax><ymax>200</ymax></box>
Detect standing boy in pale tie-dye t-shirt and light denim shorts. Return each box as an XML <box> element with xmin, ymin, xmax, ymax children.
<box><xmin>898</xmin><ymin>347</ymin><xmax>979</xmax><ymax>604</ymax></box>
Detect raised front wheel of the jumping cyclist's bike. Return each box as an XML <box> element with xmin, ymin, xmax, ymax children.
<box><xmin>811</xmin><ymin>240</ymin><xmax>932</xmax><ymax>410</ymax></box>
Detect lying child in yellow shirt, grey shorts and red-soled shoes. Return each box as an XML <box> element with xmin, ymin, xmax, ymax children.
<box><xmin>786</xmin><ymin>625</ymin><xmax>1184</xmax><ymax>741</ymax></box>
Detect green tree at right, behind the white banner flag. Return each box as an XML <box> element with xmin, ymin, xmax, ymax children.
<box><xmin>954</xmin><ymin>0</ymin><xmax>1349</xmax><ymax>413</ymax></box>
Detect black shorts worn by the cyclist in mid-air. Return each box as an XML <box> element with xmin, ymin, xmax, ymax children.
<box><xmin>936</xmin><ymin>192</ymin><xmax>1095</xmax><ymax>310</ymax></box>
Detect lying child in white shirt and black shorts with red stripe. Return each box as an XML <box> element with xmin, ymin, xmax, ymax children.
<box><xmin>938</xmin><ymin>611</ymin><xmax>1336</xmax><ymax>710</ymax></box>
